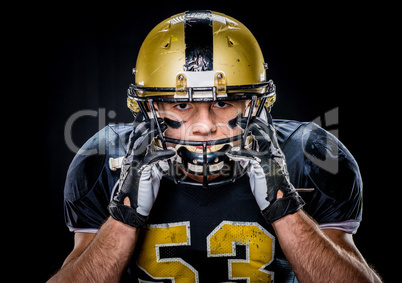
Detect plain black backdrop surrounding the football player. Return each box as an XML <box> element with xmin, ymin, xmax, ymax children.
<box><xmin>15</xmin><ymin>1</ymin><xmax>400</xmax><ymax>282</ymax></box>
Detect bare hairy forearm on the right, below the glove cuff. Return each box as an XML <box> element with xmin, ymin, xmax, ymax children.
<box><xmin>273</xmin><ymin>211</ymin><xmax>381</xmax><ymax>282</ymax></box>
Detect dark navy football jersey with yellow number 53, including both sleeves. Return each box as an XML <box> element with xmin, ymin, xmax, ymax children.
<box><xmin>65</xmin><ymin>120</ymin><xmax>362</xmax><ymax>282</ymax></box>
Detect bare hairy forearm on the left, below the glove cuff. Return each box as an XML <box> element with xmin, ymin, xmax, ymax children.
<box><xmin>48</xmin><ymin>217</ymin><xmax>138</xmax><ymax>283</ymax></box>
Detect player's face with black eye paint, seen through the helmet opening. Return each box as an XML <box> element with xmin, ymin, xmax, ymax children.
<box><xmin>155</xmin><ymin>100</ymin><xmax>248</xmax><ymax>146</ymax></box>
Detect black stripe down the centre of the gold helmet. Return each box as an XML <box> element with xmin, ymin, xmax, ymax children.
<box><xmin>184</xmin><ymin>11</ymin><xmax>213</xmax><ymax>72</ymax></box>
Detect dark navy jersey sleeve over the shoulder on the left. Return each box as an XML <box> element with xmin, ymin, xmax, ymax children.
<box><xmin>64</xmin><ymin>126</ymin><xmax>129</xmax><ymax>231</ymax></box>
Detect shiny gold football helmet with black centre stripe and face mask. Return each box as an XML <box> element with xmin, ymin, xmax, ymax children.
<box><xmin>127</xmin><ymin>11</ymin><xmax>276</xmax><ymax>187</ymax></box>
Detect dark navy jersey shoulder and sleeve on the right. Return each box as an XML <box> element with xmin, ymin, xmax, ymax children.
<box><xmin>274</xmin><ymin>120</ymin><xmax>362</xmax><ymax>233</ymax></box>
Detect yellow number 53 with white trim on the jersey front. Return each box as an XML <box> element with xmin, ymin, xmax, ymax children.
<box><xmin>138</xmin><ymin>221</ymin><xmax>275</xmax><ymax>283</ymax></box>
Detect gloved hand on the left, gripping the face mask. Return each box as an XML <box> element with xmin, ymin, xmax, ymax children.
<box><xmin>109</xmin><ymin>116</ymin><xmax>176</xmax><ymax>227</ymax></box>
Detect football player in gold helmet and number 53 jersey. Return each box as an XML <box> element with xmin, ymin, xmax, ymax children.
<box><xmin>50</xmin><ymin>11</ymin><xmax>380</xmax><ymax>282</ymax></box>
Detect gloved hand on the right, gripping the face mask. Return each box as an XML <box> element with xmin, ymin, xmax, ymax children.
<box><xmin>226</xmin><ymin>114</ymin><xmax>304</xmax><ymax>223</ymax></box>
